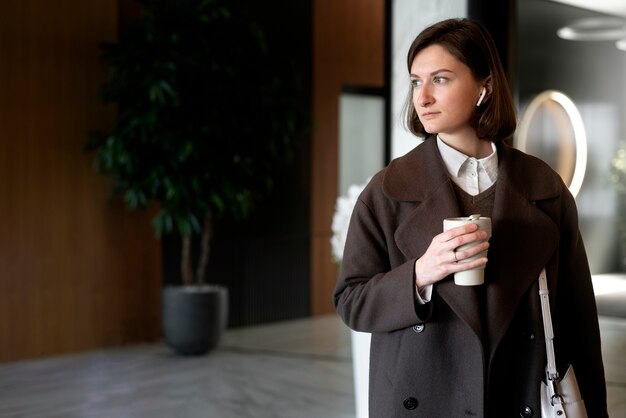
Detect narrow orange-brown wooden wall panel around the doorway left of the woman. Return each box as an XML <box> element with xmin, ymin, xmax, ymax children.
<box><xmin>311</xmin><ymin>0</ymin><xmax>385</xmax><ymax>315</ymax></box>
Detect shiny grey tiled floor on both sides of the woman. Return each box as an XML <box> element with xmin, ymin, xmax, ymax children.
<box><xmin>0</xmin><ymin>315</ymin><xmax>626</xmax><ymax>418</ymax></box>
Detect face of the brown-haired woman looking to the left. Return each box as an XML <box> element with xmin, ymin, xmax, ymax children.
<box><xmin>410</xmin><ymin>45</ymin><xmax>483</xmax><ymax>139</ymax></box>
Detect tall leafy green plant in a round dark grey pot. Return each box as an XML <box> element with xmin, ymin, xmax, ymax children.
<box><xmin>87</xmin><ymin>0</ymin><xmax>299</xmax><ymax>354</ymax></box>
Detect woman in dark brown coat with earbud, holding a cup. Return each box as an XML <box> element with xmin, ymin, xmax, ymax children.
<box><xmin>333</xmin><ymin>19</ymin><xmax>607</xmax><ymax>418</ymax></box>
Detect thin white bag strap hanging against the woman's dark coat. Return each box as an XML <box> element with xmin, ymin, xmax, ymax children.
<box><xmin>539</xmin><ymin>268</ymin><xmax>565</xmax><ymax>418</ymax></box>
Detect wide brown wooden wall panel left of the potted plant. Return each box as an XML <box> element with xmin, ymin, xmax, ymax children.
<box><xmin>0</xmin><ymin>0</ymin><xmax>161</xmax><ymax>362</ymax></box>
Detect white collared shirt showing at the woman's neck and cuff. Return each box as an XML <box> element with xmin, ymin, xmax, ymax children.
<box><xmin>416</xmin><ymin>136</ymin><xmax>498</xmax><ymax>305</ymax></box>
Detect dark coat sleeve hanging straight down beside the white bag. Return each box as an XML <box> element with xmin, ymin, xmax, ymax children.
<box><xmin>554</xmin><ymin>190</ymin><xmax>608</xmax><ymax>417</ymax></box>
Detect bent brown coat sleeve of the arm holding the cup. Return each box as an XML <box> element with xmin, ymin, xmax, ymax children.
<box><xmin>333</xmin><ymin>184</ymin><xmax>424</xmax><ymax>332</ymax></box>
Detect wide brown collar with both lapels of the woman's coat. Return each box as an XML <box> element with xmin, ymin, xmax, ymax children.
<box><xmin>383</xmin><ymin>137</ymin><xmax>563</xmax><ymax>356</ymax></box>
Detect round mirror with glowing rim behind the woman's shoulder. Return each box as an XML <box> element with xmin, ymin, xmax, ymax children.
<box><xmin>515</xmin><ymin>90</ymin><xmax>587</xmax><ymax>196</ymax></box>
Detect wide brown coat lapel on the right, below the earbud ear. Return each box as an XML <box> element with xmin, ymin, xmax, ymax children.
<box><xmin>486</xmin><ymin>147</ymin><xmax>559</xmax><ymax>360</ymax></box>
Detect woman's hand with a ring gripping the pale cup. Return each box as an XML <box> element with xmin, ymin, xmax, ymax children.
<box><xmin>415</xmin><ymin>224</ymin><xmax>489</xmax><ymax>289</ymax></box>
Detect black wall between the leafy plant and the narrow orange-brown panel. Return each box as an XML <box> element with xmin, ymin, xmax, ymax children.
<box><xmin>163</xmin><ymin>0</ymin><xmax>312</xmax><ymax>327</ymax></box>
